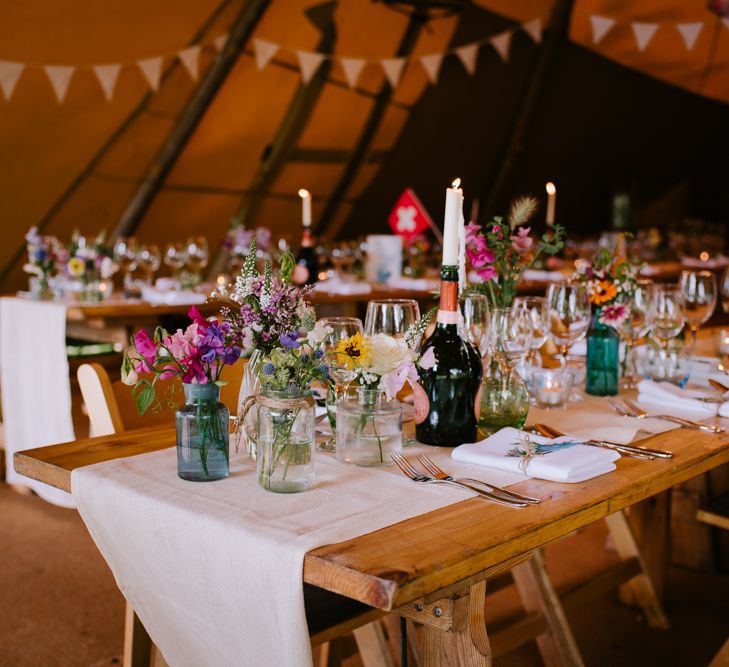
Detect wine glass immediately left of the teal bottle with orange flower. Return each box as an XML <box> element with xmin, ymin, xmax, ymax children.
<box><xmin>547</xmin><ymin>283</ymin><xmax>591</xmax><ymax>368</ymax></box>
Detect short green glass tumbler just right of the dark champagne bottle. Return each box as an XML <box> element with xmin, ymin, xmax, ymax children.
<box><xmin>478</xmin><ymin>372</ymin><xmax>529</xmax><ymax>438</ymax></box>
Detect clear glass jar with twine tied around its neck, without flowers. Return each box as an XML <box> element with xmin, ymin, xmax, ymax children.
<box><xmin>256</xmin><ymin>387</ymin><xmax>316</xmax><ymax>493</ymax></box>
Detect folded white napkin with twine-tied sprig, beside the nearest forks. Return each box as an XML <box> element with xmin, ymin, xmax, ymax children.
<box><xmin>451</xmin><ymin>427</ymin><xmax>620</xmax><ymax>483</ymax></box>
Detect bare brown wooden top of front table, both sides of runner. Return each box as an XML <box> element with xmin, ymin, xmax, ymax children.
<box><xmin>15</xmin><ymin>418</ymin><xmax>729</xmax><ymax>610</ymax></box>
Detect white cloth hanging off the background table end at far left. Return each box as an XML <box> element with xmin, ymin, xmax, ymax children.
<box><xmin>0</xmin><ymin>298</ymin><xmax>75</xmax><ymax>507</ymax></box>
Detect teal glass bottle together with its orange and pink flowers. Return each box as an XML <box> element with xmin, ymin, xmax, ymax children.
<box><xmin>573</xmin><ymin>244</ymin><xmax>640</xmax><ymax>396</ymax></box>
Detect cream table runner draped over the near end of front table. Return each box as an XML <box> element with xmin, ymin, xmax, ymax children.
<box><xmin>71</xmin><ymin>446</ymin><xmax>532</xmax><ymax>667</ymax></box>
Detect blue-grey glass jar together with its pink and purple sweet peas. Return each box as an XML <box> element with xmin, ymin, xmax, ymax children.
<box><xmin>122</xmin><ymin>306</ymin><xmax>240</xmax><ymax>482</ymax></box>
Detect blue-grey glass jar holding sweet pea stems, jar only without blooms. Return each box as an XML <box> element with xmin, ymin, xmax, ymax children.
<box><xmin>176</xmin><ymin>384</ymin><xmax>230</xmax><ymax>482</ymax></box>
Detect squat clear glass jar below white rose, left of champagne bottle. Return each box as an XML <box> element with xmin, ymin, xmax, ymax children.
<box><xmin>336</xmin><ymin>389</ymin><xmax>402</xmax><ymax>466</ymax></box>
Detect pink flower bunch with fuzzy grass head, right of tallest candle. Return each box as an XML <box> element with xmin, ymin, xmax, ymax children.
<box><xmin>466</xmin><ymin>197</ymin><xmax>564</xmax><ymax>308</ymax></box>
